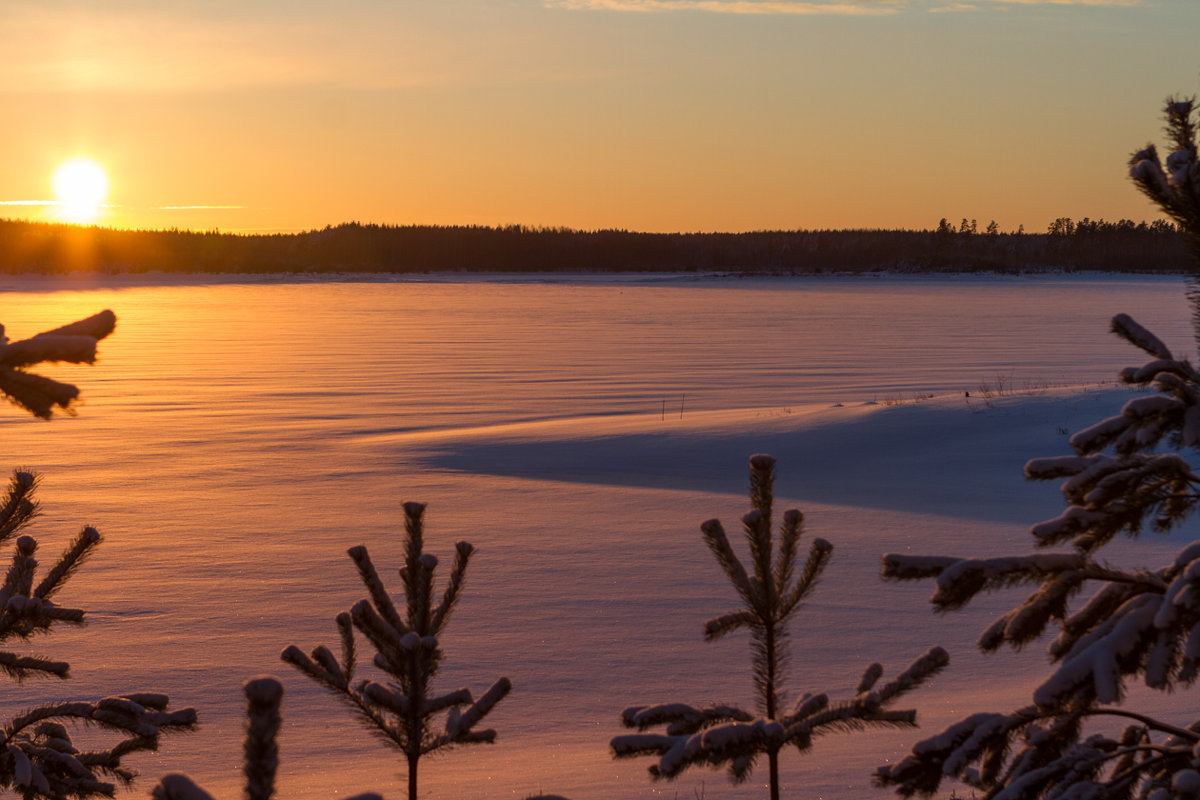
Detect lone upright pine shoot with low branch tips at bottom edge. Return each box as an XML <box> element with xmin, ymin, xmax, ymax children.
<box><xmin>150</xmin><ymin>675</ymin><xmax>382</xmax><ymax>800</ymax></box>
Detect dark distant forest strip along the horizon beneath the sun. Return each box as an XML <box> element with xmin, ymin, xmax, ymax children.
<box><xmin>0</xmin><ymin>217</ymin><xmax>1192</xmax><ymax>275</ymax></box>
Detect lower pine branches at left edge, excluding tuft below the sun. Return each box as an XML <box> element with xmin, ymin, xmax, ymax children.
<box><xmin>0</xmin><ymin>471</ymin><xmax>196</xmax><ymax>800</ymax></box>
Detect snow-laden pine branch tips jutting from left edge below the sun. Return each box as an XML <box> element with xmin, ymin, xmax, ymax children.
<box><xmin>0</xmin><ymin>311</ymin><xmax>116</xmax><ymax>420</ymax></box>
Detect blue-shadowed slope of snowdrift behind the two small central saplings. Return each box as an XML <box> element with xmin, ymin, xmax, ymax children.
<box><xmin>422</xmin><ymin>390</ymin><xmax>1129</xmax><ymax>523</ymax></box>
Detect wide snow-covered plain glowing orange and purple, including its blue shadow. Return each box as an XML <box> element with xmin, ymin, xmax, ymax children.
<box><xmin>0</xmin><ymin>276</ymin><xmax>1192</xmax><ymax>800</ymax></box>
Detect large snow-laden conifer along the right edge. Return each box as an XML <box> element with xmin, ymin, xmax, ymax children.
<box><xmin>877</xmin><ymin>100</ymin><xmax>1200</xmax><ymax>800</ymax></box>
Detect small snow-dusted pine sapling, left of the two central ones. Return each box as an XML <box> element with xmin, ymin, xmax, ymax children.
<box><xmin>282</xmin><ymin>503</ymin><xmax>512</xmax><ymax>800</ymax></box>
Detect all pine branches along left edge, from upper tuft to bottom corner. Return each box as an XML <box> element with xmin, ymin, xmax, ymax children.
<box><xmin>0</xmin><ymin>311</ymin><xmax>196</xmax><ymax>800</ymax></box>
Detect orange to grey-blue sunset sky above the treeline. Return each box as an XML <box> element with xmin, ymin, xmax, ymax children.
<box><xmin>0</xmin><ymin>0</ymin><xmax>1200</xmax><ymax>233</ymax></box>
